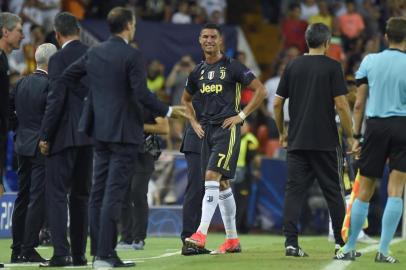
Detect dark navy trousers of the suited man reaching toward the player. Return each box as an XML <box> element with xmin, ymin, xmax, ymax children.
<box><xmin>89</xmin><ymin>141</ymin><xmax>138</xmax><ymax>257</ymax></box>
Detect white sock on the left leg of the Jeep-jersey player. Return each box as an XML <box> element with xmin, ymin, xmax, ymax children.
<box><xmin>197</xmin><ymin>181</ymin><xmax>220</xmax><ymax>234</ymax></box>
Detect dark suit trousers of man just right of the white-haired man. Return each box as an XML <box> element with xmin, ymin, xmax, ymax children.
<box><xmin>46</xmin><ymin>146</ymin><xmax>93</xmax><ymax>256</ymax></box>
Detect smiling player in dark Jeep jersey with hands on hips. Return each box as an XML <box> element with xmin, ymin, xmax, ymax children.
<box><xmin>182</xmin><ymin>24</ymin><xmax>266</xmax><ymax>254</ymax></box>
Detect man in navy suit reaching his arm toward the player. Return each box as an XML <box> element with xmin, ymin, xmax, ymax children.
<box><xmin>40</xmin><ymin>7</ymin><xmax>185</xmax><ymax>268</ymax></box>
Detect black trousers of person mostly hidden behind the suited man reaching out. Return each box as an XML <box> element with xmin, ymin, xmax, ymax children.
<box><xmin>121</xmin><ymin>153</ymin><xmax>154</xmax><ymax>244</ymax></box>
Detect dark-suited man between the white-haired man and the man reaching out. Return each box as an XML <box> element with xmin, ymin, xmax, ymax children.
<box><xmin>41</xmin><ymin>12</ymin><xmax>93</xmax><ymax>267</ymax></box>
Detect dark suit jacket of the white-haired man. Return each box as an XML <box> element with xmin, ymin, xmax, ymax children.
<box><xmin>9</xmin><ymin>70</ymin><xmax>48</xmax><ymax>157</ymax></box>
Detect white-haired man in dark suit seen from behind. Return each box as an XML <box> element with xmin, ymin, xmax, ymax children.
<box><xmin>9</xmin><ymin>43</ymin><xmax>57</xmax><ymax>263</ymax></box>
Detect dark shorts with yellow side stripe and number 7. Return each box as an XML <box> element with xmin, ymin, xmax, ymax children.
<box><xmin>201</xmin><ymin>124</ymin><xmax>241</xmax><ymax>179</ymax></box>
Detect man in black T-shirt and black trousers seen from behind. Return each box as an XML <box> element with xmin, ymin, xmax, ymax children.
<box><xmin>274</xmin><ymin>23</ymin><xmax>353</xmax><ymax>257</ymax></box>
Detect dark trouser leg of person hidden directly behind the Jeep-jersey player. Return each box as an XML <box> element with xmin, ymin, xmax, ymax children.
<box><xmin>180</xmin><ymin>152</ymin><xmax>204</xmax><ymax>242</ymax></box>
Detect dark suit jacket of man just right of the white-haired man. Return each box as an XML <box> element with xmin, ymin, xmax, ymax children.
<box><xmin>41</xmin><ymin>40</ymin><xmax>92</xmax><ymax>153</ymax></box>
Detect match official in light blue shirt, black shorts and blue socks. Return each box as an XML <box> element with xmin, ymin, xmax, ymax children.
<box><xmin>334</xmin><ymin>17</ymin><xmax>406</xmax><ymax>263</ymax></box>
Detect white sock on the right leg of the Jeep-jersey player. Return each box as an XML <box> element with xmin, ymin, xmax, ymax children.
<box><xmin>219</xmin><ymin>188</ymin><xmax>238</xmax><ymax>239</ymax></box>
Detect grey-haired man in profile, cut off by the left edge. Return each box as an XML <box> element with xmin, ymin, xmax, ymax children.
<box><xmin>0</xmin><ymin>12</ymin><xmax>24</xmax><ymax>196</ymax></box>
